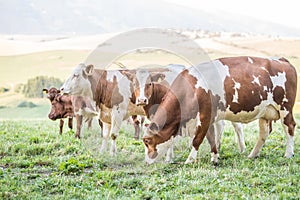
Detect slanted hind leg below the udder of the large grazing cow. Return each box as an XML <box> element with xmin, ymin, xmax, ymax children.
<box><xmin>248</xmin><ymin>118</ymin><xmax>270</xmax><ymax>158</ymax></box>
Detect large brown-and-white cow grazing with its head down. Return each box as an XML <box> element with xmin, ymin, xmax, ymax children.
<box><xmin>143</xmin><ymin>56</ymin><xmax>297</xmax><ymax>164</ymax></box>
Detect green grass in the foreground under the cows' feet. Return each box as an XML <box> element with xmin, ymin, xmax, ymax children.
<box><xmin>0</xmin><ymin>116</ymin><xmax>300</xmax><ymax>199</ymax></box>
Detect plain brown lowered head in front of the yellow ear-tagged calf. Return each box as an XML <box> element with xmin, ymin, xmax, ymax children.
<box><xmin>48</xmin><ymin>95</ymin><xmax>73</xmax><ymax>120</ymax></box>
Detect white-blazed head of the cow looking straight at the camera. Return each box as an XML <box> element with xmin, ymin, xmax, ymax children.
<box><xmin>133</xmin><ymin>69</ymin><xmax>165</xmax><ymax>106</ymax></box>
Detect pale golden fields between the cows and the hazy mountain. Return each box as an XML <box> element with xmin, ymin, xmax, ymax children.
<box><xmin>0</xmin><ymin>31</ymin><xmax>300</xmax><ymax>119</ymax></box>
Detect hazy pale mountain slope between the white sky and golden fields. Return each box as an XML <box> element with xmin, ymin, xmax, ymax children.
<box><xmin>0</xmin><ymin>0</ymin><xmax>300</xmax><ymax>36</ymax></box>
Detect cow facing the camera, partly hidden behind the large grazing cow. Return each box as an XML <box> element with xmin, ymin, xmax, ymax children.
<box><xmin>133</xmin><ymin>64</ymin><xmax>246</xmax><ymax>161</ymax></box>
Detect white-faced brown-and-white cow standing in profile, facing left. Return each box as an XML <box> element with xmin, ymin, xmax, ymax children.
<box><xmin>61</xmin><ymin>64</ymin><xmax>145</xmax><ymax>156</ymax></box>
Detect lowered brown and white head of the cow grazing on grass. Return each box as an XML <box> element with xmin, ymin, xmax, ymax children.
<box><xmin>143</xmin><ymin>122</ymin><xmax>173</xmax><ymax>164</ymax></box>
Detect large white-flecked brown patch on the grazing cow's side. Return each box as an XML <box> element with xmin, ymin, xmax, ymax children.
<box><xmin>220</xmin><ymin>57</ymin><xmax>280</xmax><ymax>114</ymax></box>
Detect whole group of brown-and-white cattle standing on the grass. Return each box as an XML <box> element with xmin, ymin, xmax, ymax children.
<box><xmin>44</xmin><ymin>56</ymin><xmax>297</xmax><ymax>164</ymax></box>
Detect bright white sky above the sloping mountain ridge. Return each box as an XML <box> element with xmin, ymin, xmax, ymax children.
<box><xmin>165</xmin><ymin>0</ymin><xmax>300</xmax><ymax>30</ymax></box>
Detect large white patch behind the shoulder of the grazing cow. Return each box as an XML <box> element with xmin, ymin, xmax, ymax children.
<box><xmin>188</xmin><ymin>60</ymin><xmax>230</xmax><ymax>103</ymax></box>
